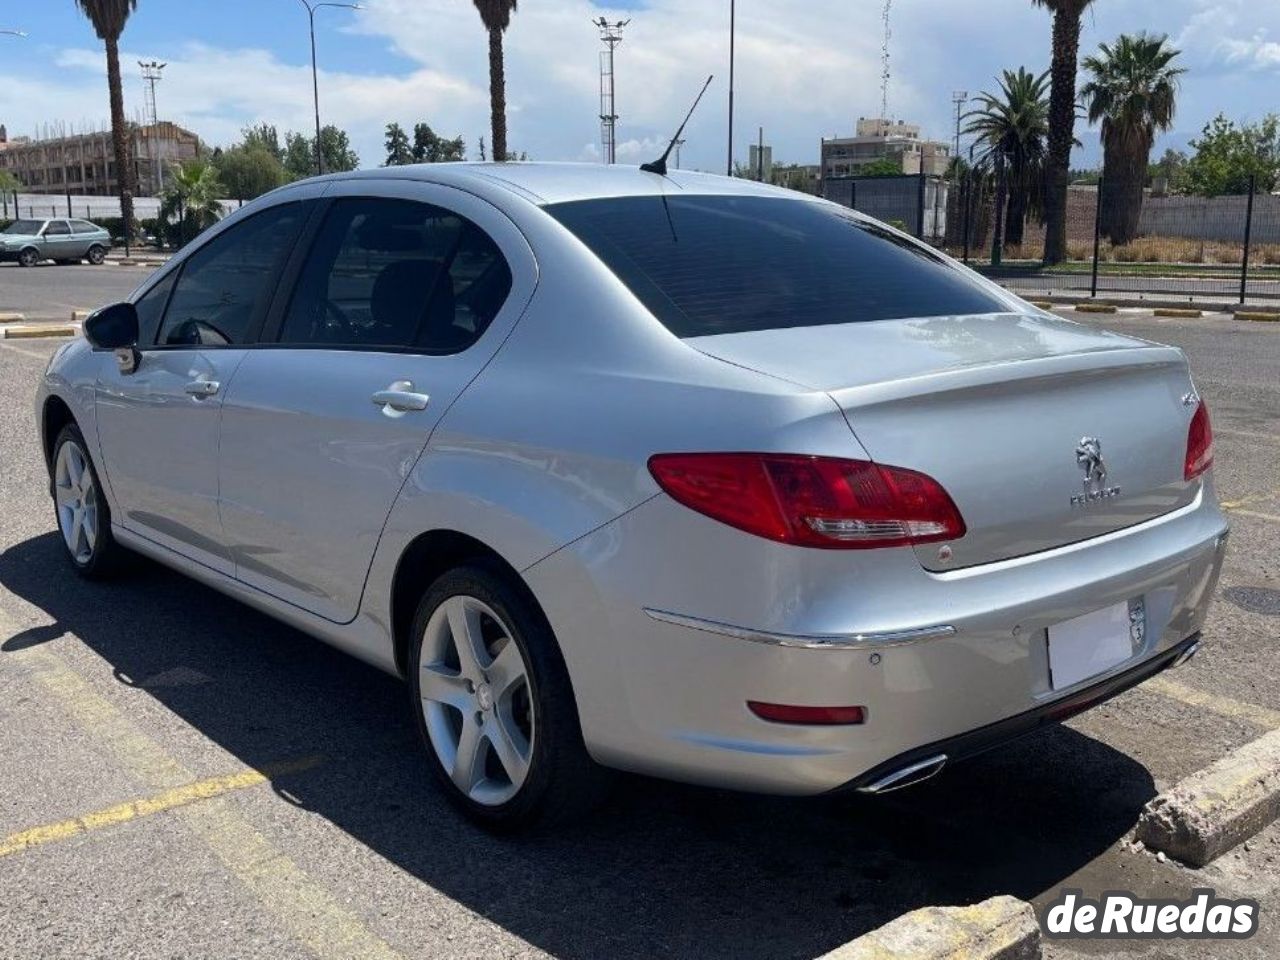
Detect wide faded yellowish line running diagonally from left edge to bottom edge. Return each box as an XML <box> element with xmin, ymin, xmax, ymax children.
<box><xmin>0</xmin><ymin>609</ymin><xmax>402</xmax><ymax>960</ymax></box>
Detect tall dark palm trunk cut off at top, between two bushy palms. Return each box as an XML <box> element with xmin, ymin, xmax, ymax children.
<box><xmin>1032</xmin><ymin>0</ymin><xmax>1093</xmax><ymax>265</ymax></box>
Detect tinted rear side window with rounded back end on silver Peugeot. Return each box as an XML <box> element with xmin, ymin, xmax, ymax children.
<box><xmin>280</xmin><ymin>197</ymin><xmax>511</xmax><ymax>353</ymax></box>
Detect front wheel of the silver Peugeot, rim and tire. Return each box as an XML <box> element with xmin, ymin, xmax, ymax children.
<box><xmin>54</xmin><ymin>424</ymin><xmax>124</xmax><ymax>579</ymax></box>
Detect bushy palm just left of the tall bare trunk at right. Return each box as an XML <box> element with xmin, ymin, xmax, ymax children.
<box><xmin>965</xmin><ymin>67</ymin><xmax>1048</xmax><ymax>252</ymax></box>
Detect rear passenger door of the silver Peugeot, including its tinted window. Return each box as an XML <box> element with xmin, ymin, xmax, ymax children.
<box><xmin>220</xmin><ymin>180</ymin><xmax>536</xmax><ymax>623</ymax></box>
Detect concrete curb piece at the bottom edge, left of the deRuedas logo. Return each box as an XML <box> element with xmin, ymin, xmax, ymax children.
<box><xmin>820</xmin><ymin>896</ymin><xmax>1041</xmax><ymax>960</ymax></box>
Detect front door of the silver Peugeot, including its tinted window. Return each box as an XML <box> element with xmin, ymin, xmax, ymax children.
<box><xmin>97</xmin><ymin>201</ymin><xmax>311</xmax><ymax>576</ymax></box>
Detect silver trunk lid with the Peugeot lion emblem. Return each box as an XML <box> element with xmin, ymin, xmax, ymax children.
<box><xmin>686</xmin><ymin>314</ymin><xmax>1199</xmax><ymax>571</ymax></box>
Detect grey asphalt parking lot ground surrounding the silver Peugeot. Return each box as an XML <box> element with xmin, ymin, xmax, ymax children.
<box><xmin>0</xmin><ymin>304</ymin><xmax>1280</xmax><ymax>960</ymax></box>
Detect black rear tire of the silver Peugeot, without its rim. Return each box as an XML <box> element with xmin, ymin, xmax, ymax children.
<box><xmin>408</xmin><ymin>562</ymin><xmax>612</xmax><ymax>833</ymax></box>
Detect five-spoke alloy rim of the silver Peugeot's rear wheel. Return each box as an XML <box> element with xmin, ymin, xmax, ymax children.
<box><xmin>419</xmin><ymin>595</ymin><xmax>536</xmax><ymax>806</ymax></box>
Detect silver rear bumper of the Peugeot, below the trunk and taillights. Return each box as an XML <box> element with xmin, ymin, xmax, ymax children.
<box><xmin>525</xmin><ymin>483</ymin><xmax>1226</xmax><ymax>795</ymax></box>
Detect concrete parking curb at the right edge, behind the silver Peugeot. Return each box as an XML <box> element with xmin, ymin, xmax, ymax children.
<box><xmin>1137</xmin><ymin>730</ymin><xmax>1280</xmax><ymax>867</ymax></box>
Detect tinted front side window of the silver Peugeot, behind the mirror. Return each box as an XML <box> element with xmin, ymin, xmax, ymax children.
<box><xmin>159</xmin><ymin>204</ymin><xmax>308</xmax><ymax>347</ymax></box>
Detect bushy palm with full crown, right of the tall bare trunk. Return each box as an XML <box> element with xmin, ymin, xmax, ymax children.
<box><xmin>1080</xmin><ymin>33</ymin><xmax>1185</xmax><ymax>246</ymax></box>
